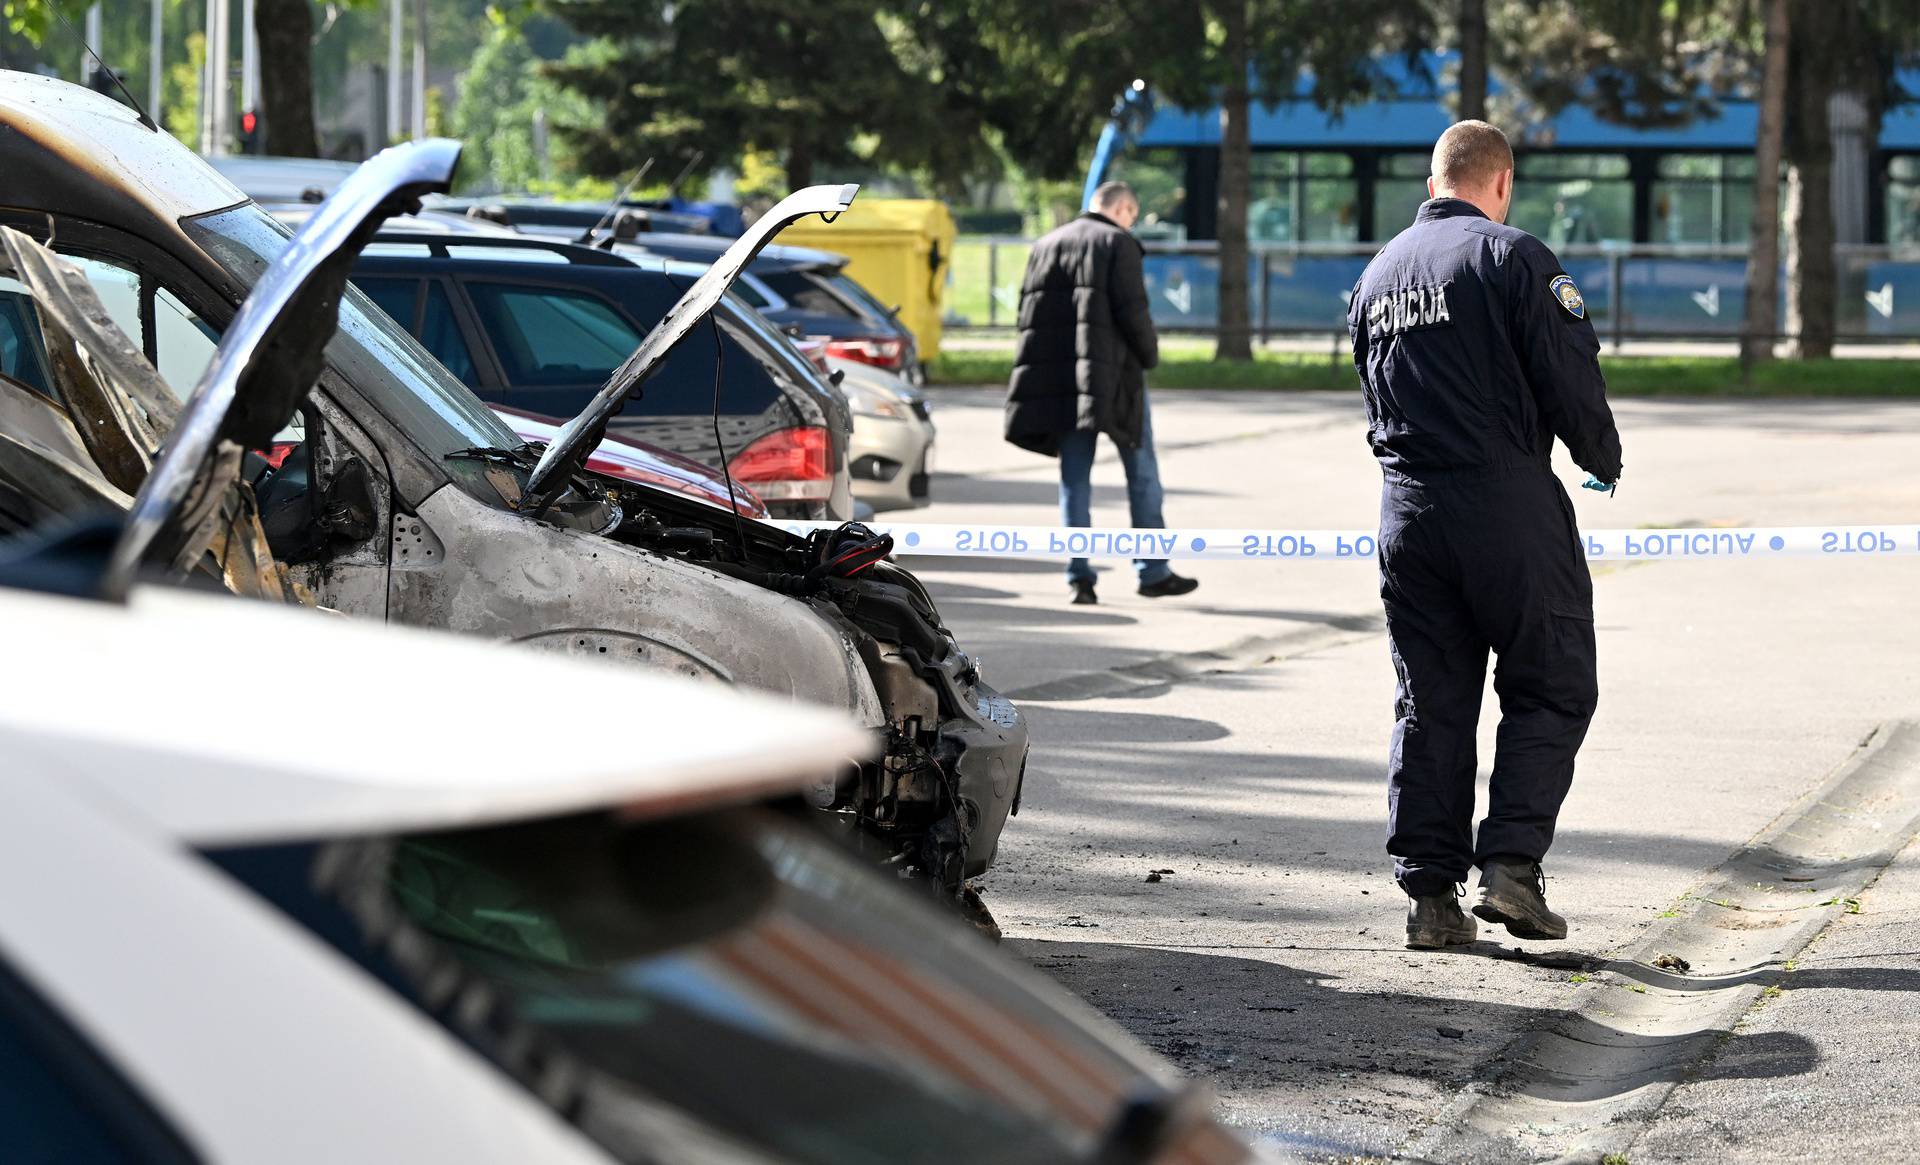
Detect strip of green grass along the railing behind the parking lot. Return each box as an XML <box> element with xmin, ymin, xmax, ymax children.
<box><xmin>927</xmin><ymin>349</ymin><xmax>1920</xmax><ymax>397</ymax></box>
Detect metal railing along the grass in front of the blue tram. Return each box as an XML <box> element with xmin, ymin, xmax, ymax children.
<box><xmin>947</xmin><ymin>236</ymin><xmax>1920</xmax><ymax>344</ymax></box>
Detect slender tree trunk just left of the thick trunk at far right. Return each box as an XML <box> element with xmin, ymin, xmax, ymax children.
<box><xmin>1786</xmin><ymin>0</ymin><xmax>1839</xmax><ymax>361</ymax></box>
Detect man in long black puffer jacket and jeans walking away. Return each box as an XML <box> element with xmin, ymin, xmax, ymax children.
<box><xmin>1006</xmin><ymin>182</ymin><xmax>1200</xmax><ymax>603</ymax></box>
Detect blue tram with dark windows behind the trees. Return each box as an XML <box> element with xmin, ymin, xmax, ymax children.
<box><xmin>1089</xmin><ymin>58</ymin><xmax>1920</xmax><ymax>340</ymax></box>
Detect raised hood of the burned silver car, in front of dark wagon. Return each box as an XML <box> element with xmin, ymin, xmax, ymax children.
<box><xmin>522</xmin><ymin>184</ymin><xmax>860</xmax><ymax>511</ymax></box>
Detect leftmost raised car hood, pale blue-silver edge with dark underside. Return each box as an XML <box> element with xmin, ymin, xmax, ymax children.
<box><xmin>104</xmin><ymin>138</ymin><xmax>461</xmax><ymax>597</ymax></box>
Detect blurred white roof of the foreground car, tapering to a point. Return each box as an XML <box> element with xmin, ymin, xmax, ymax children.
<box><xmin>0</xmin><ymin>587</ymin><xmax>870</xmax><ymax>844</ymax></box>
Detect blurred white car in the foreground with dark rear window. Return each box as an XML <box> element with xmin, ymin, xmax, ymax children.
<box><xmin>0</xmin><ymin>575</ymin><xmax>1248</xmax><ymax>1165</ymax></box>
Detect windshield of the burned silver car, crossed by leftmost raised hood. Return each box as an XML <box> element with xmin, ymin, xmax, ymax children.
<box><xmin>180</xmin><ymin>203</ymin><xmax>520</xmax><ymax>459</ymax></box>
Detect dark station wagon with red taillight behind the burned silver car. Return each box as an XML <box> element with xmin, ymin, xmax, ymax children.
<box><xmin>353</xmin><ymin>228</ymin><xmax>854</xmax><ymax>518</ymax></box>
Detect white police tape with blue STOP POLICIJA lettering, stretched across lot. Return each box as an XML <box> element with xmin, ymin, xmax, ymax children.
<box><xmin>768</xmin><ymin>520</ymin><xmax>1920</xmax><ymax>562</ymax></box>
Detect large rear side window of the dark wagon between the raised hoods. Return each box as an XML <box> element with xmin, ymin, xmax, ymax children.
<box><xmin>468</xmin><ymin>282</ymin><xmax>639</xmax><ymax>386</ymax></box>
